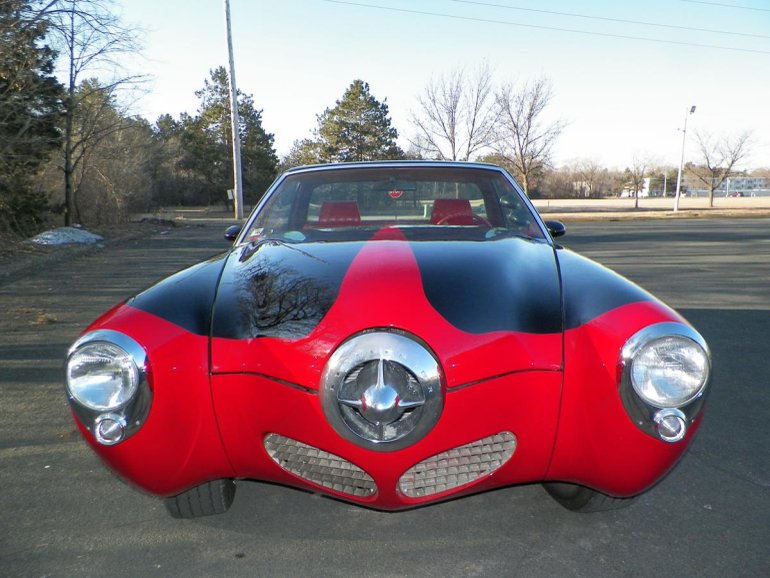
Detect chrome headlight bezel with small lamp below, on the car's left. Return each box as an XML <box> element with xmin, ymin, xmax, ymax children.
<box><xmin>65</xmin><ymin>329</ymin><xmax>152</xmax><ymax>446</ymax></box>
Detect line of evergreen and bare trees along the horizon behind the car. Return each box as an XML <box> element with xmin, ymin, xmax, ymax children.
<box><xmin>0</xmin><ymin>0</ymin><xmax>751</xmax><ymax>235</ymax></box>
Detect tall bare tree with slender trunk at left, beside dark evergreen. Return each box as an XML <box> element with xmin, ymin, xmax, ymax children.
<box><xmin>40</xmin><ymin>0</ymin><xmax>142</xmax><ymax>225</ymax></box>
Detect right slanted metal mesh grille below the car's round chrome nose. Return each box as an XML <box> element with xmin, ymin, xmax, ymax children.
<box><xmin>398</xmin><ymin>432</ymin><xmax>516</xmax><ymax>498</ymax></box>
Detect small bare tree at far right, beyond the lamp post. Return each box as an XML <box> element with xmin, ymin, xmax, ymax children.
<box><xmin>691</xmin><ymin>132</ymin><xmax>751</xmax><ymax>207</ymax></box>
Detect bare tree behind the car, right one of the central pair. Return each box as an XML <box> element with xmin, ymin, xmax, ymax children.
<box><xmin>496</xmin><ymin>77</ymin><xmax>564</xmax><ymax>194</ymax></box>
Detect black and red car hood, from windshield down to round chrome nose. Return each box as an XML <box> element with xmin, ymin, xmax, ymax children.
<box><xmin>211</xmin><ymin>229</ymin><xmax>562</xmax><ymax>382</ymax></box>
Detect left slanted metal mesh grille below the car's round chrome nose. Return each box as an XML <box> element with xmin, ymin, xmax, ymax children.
<box><xmin>265</xmin><ymin>433</ymin><xmax>377</xmax><ymax>498</ymax></box>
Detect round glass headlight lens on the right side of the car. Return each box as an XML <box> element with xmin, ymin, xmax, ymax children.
<box><xmin>630</xmin><ymin>335</ymin><xmax>710</xmax><ymax>408</ymax></box>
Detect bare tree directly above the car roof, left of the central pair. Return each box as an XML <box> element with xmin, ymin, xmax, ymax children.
<box><xmin>410</xmin><ymin>62</ymin><xmax>497</xmax><ymax>161</ymax></box>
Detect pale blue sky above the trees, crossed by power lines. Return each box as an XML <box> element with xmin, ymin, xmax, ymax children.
<box><xmin>116</xmin><ymin>0</ymin><xmax>770</xmax><ymax>168</ymax></box>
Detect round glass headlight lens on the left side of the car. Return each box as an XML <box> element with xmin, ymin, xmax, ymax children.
<box><xmin>67</xmin><ymin>341</ymin><xmax>144</xmax><ymax>411</ymax></box>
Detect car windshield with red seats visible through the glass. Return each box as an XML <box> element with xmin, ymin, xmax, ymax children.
<box><xmin>243</xmin><ymin>165</ymin><xmax>544</xmax><ymax>242</ymax></box>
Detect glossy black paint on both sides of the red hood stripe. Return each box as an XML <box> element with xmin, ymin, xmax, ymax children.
<box><xmin>128</xmin><ymin>232</ymin><xmax>654</xmax><ymax>339</ymax></box>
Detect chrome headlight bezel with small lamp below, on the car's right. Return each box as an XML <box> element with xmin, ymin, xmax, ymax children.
<box><xmin>619</xmin><ymin>322</ymin><xmax>711</xmax><ymax>443</ymax></box>
